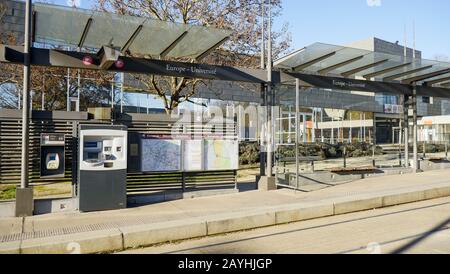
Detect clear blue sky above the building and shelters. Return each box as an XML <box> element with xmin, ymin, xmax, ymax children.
<box><xmin>52</xmin><ymin>0</ymin><xmax>450</xmax><ymax>59</ymax></box>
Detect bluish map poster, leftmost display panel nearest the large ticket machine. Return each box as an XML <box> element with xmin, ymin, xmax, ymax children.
<box><xmin>141</xmin><ymin>138</ymin><xmax>181</xmax><ymax>172</ymax></box>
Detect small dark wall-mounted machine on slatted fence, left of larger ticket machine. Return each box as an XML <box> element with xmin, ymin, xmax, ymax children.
<box><xmin>41</xmin><ymin>133</ymin><xmax>66</xmax><ymax>178</ymax></box>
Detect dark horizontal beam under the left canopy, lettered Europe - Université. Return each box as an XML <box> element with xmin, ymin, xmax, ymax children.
<box><xmin>0</xmin><ymin>44</ymin><xmax>267</xmax><ymax>84</ymax></box>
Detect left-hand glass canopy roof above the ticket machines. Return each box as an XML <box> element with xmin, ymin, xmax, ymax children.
<box><xmin>33</xmin><ymin>3</ymin><xmax>232</xmax><ymax>59</ymax></box>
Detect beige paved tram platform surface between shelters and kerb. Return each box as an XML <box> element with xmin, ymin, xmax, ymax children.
<box><xmin>0</xmin><ymin>170</ymin><xmax>450</xmax><ymax>255</ymax></box>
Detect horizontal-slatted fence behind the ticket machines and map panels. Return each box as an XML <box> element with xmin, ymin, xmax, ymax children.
<box><xmin>0</xmin><ymin>109</ymin><xmax>236</xmax><ymax>195</ymax></box>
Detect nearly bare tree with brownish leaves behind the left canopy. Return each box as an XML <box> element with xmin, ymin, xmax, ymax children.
<box><xmin>96</xmin><ymin>0</ymin><xmax>291</xmax><ymax>114</ymax></box>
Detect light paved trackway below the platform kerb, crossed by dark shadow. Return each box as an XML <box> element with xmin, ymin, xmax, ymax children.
<box><xmin>121</xmin><ymin>198</ymin><xmax>450</xmax><ymax>254</ymax></box>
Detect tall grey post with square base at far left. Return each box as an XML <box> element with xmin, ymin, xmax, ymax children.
<box><xmin>15</xmin><ymin>0</ymin><xmax>33</xmax><ymax>217</ymax></box>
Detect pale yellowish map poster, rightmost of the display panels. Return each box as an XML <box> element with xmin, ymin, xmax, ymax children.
<box><xmin>205</xmin><ymin>140</ymin><xmax>239</xmax><ymax>170</ymax></box>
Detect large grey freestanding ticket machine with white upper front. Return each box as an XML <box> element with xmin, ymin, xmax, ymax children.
<box><xmin>78</xmin><ymin>125</ymin><xmax>128</xmax><ymax>212</ymax></box>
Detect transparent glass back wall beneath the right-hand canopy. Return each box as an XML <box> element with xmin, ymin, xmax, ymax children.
<box><xmin>276</xmin><ymin>85</ymin><xmax>414</xmax><ymax>191</ymax></box>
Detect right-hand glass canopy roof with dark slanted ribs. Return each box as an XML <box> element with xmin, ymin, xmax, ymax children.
<box><xmin>274</xmin><ymin>43</ymin><xmax>450</xmax><ymax>87</ymax></box>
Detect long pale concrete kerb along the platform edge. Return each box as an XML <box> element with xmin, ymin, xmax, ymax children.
<box><xmin>0</xmin><ymin>183</ymin><xmax>450</xmax><ymax>254</ymax></box>
